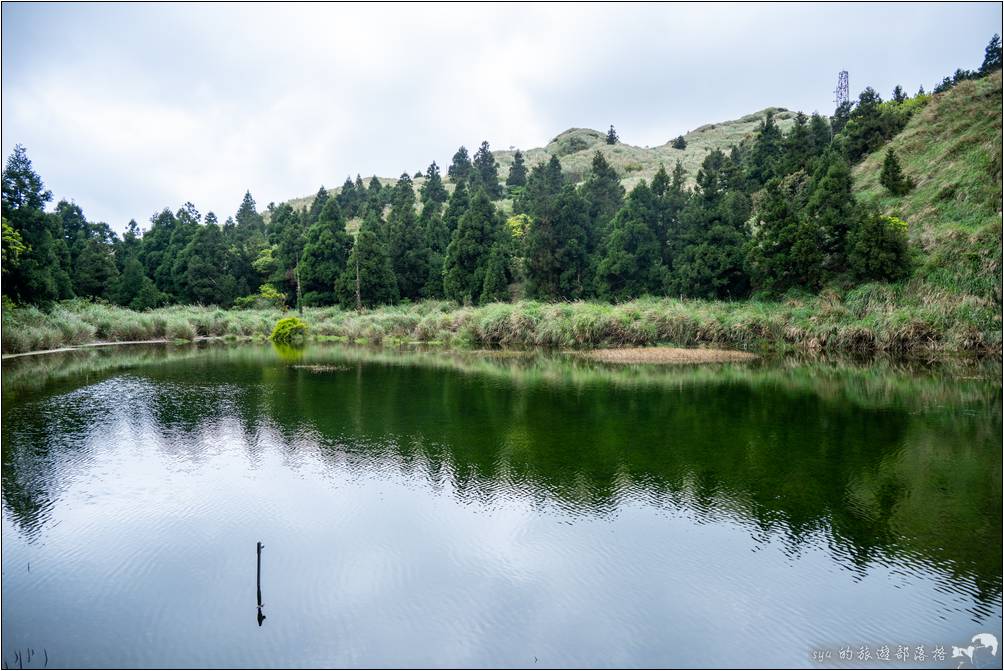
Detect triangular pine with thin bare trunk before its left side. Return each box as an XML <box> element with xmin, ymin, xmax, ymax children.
<box><xmin>335</xmin><ymin>209</ymin><xmax>398</xmax><ymax>309</ymax></box>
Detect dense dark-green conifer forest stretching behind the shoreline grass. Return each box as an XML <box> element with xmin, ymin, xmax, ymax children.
<box><xmin>2</xmin><ymin>35</ymin><xmax>1001</xmax><ymax>309</ymax></box>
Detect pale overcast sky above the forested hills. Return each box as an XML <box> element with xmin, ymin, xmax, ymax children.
<box><xmin>2</xmin><ymin>3</ymin><xmax>1001</xmax><ymax>230</ymax></box>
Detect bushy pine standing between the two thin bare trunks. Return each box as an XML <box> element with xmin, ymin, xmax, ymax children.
<box><xmin>300</xmin><ymin>197</ymin><xmax>354</xmax><ymax>305</ymax></box>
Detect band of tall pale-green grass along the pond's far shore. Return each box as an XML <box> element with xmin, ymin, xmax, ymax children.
<box><xmin>2</xmin><ymin>279</ymin><xmax>1002</xmax><ymax>354</ymax></box>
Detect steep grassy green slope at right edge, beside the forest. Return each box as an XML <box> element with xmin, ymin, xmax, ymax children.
<box><xmin>853</xmin><ymin>71</ymin><xmax>1002</xmax><ymax>299</ymax></box>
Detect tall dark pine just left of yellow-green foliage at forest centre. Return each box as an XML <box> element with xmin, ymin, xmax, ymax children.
<box><xmin>443</xmin><ymin>189</ymin><xmax>501</xmax><ymax>304</ymax></box>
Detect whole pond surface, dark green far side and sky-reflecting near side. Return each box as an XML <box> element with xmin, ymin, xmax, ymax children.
<box><xmin>2</xmin><ymin>345</ymin><xmax>1004</xmax><ymax>668</ymax></box>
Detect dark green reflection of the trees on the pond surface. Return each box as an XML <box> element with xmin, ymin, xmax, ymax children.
<box><xmin>3</xmin><ymin>341</ymin><xmax>1001</xmax><ymax>604</ymax></box>
